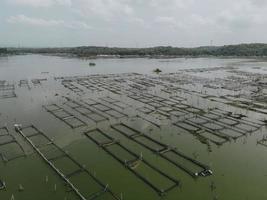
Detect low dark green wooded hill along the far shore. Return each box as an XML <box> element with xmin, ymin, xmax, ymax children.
<box><xmin>4</xmin><ymin>43</ymin><xmax>267</xmax><ymax>57</ymax></box>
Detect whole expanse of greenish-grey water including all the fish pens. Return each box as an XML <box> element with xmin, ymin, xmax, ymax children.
<box><xmin>0</xmin><ymin>55</ymin><xmax>267</xmax><ymax>200</ymax></box>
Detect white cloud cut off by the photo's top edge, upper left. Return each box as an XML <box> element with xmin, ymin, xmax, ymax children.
<box><xmin>7</xmin><ymin>0</ymin><xmax>72</xmax><ymax>7</ymax></box>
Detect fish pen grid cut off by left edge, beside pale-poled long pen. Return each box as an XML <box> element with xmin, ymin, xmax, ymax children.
<box><xmin>0</xmin><ymin>127</ymin><xmax>25</xmax><ymax>162</ymax></box>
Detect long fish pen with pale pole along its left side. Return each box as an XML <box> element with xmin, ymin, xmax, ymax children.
<box><xmin>15</xmin><ymin>125</ymin><xmax>120</xmax><ymax>200</ymax></box>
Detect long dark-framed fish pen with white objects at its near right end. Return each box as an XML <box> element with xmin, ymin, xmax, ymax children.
<box><xmin>111</xmin><ymin>123</ymin><xmax>212</xmax><ymax>177</ymax></box>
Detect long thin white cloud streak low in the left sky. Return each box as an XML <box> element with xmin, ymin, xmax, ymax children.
<box><xmin>7</xmin><ymin>15</ymin><xmax>92</xmax><ymax>29</ymax></box>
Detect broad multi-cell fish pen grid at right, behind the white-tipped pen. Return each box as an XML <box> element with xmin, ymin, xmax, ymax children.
<box><xmin>173</xmin><ymin>110</ymin><xmax>263</xmax><ymax>145</ymax></box>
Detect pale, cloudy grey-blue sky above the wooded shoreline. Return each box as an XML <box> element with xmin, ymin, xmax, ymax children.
<box><xmin>0</xmin><ymin>0</ymin><xmax>267</xmax><ymax>47</ymax></box>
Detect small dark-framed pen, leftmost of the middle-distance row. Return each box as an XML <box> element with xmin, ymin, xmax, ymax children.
<box><xmin>43</xmin><ymin>104</ymin><xmax>86</xmax><ymax>129</ymax></box>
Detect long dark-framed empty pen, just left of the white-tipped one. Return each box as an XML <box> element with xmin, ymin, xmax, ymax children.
<box><xmin>85</xmin><ymin>129</ymin><xmax>179</xmax><ymax>196</ymax></box>
